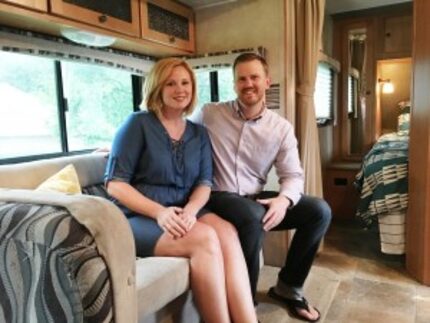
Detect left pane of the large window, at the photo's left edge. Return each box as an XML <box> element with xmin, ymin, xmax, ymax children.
<box><xmin>0</xmin><ymin>52</ymin><xmax>61</xmax><ymax>159</ymax></box>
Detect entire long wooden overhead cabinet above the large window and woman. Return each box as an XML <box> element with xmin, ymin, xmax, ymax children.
<box><xmin>0</xmin><ymin>0</ymin><xmax>195</xmax><ymax>56</ymax></box>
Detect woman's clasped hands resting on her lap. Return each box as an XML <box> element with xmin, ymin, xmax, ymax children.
<box><xmin>156</xmin><ymin>205</ymin><xmax>198</xmax><ymax>239</ymax></box>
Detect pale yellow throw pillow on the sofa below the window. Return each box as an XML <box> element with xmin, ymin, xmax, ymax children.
<box><xmin>36</xmin><ymin>164</ymin><xmax>81</xmax><ymax>194</ymax></box>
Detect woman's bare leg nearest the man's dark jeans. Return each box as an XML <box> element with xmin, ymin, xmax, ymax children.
<box><xmin>198</xmin><ymin>213</ymin><xmax>257</xmax><ymax>323</ymax></box>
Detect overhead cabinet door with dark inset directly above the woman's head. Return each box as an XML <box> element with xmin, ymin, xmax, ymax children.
<box><xmin>140</xmin><ymin>0</ymin><xmax>195</xmax><ymax>52</ymax></box>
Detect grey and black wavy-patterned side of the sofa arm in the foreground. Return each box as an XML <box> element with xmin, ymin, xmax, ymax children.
<box><xmin>0</xmin><ymin>202</ymin><xmax>114</xmax><ymax>322</ymax></box>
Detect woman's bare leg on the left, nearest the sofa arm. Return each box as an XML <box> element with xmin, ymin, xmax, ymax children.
<box><xmin>154</xmin><ymin>222</ymin><xmax>230</xmax><ymax>323</ymax></box>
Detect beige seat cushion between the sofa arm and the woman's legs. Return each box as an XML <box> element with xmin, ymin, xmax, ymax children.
<box><xmin>136</xmin><ymin>257</ymin><xmax>190</xmax><ymax>318</ymax></box>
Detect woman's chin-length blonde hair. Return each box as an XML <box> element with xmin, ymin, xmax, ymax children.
<box><xmin>141</xmin><ymin>57</ymin><xmax>197</xmax><ymax>116</ymax></box>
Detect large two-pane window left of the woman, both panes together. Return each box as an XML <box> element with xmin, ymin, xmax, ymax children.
<box><xmin>0</xmin><ymin>51</ymin><xmax>135</xmax><ymax>163</ymax></box>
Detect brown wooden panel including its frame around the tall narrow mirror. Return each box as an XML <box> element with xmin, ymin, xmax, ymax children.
<box><xmin>333</xmin><ymin>19</ymin><xmax>375</xmax><ymax>162</ymax></box>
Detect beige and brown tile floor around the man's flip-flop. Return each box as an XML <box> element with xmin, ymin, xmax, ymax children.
<box><xmin>257</xmin><ymin>221</ymin><xmax>430</xmax><ymax>323</ymax></box>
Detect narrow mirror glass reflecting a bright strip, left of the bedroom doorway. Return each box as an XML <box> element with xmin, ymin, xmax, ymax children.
<box><xmin>346</xmin><ymin>28</ymin><xmax>367</xmax><ymax>155</ymax></box>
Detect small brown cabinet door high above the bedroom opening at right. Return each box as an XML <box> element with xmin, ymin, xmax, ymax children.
<box><xmin>384</xmin><ymin>16</ymin><xmax>412</xmax><ymax>56</ymax></box>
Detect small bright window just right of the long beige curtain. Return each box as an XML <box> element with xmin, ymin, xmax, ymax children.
<box><xmin>314</xmin><ymin>62</ymin><xmax>335</xmax><ymax>124</ymax></box>
